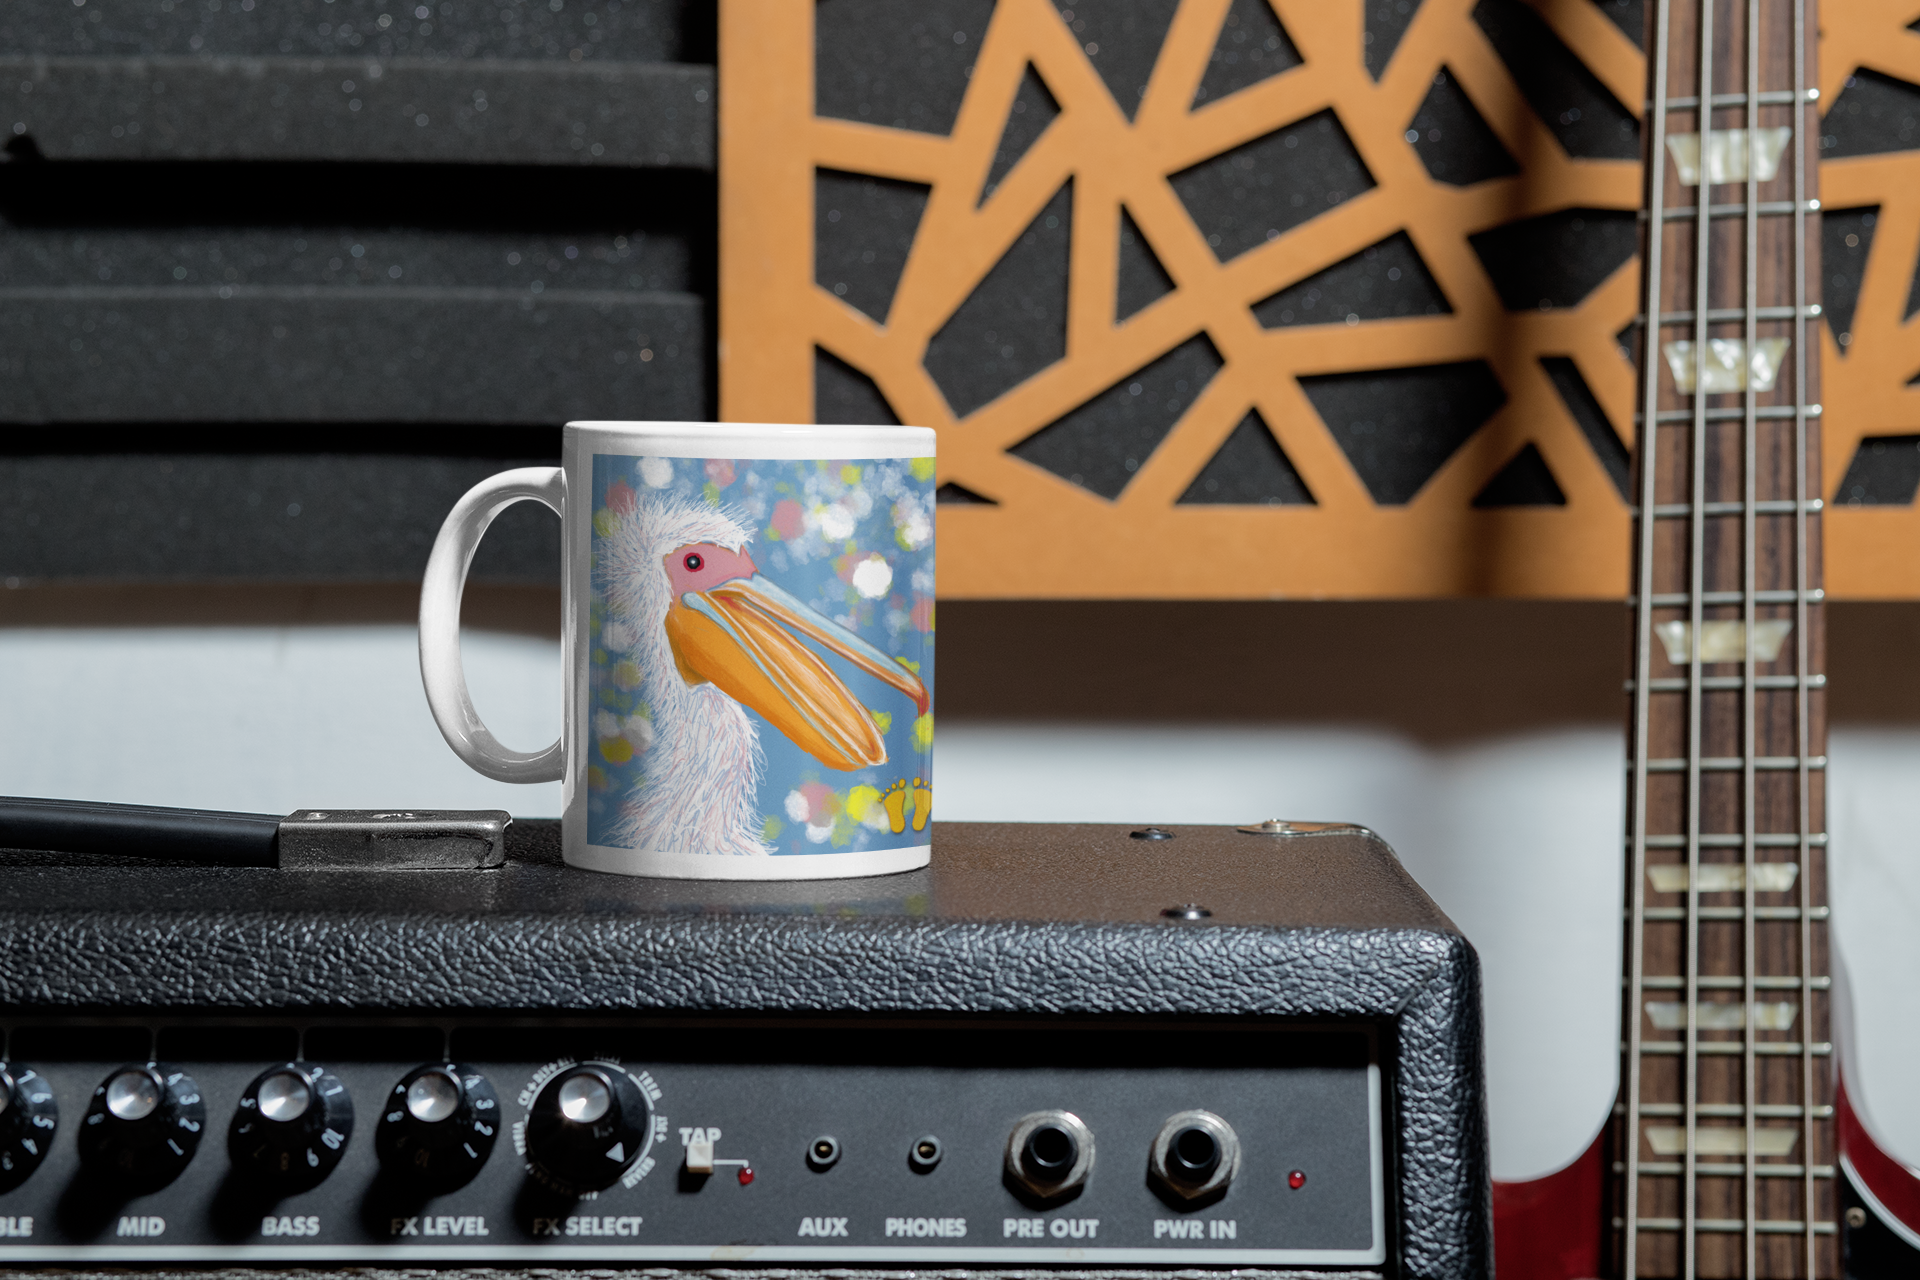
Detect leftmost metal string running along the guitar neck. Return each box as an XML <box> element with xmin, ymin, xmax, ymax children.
<box><xmin>1620</xmin><ymin>0</ymin><xmax>1674</xmax><ymax>1280</ymax></box>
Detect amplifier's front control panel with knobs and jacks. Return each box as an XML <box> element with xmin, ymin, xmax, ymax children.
<box><xmin>0</xmin><ymin>1019</ymin><xmax>1390</xmax><ymax>1267</ymax></box>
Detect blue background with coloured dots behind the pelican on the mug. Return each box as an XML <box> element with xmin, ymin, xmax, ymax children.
<box><xmin>582</xmin><ymin>453</ymin><xmax>935</xmax><ymax>856</ymax></box>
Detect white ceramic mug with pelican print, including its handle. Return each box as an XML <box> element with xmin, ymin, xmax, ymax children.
<box><xmin>420</xmin><ymin>422</ymin><xmax>933</xmax><ymax>879</ymax></box>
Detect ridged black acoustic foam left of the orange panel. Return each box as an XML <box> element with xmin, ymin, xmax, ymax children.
<box><xmin>0</xmin><ymin>0</ymin><xmax>716</xmax><ymax>581</ymax></box>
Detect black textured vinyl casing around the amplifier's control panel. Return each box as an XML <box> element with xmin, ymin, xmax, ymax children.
<box><xmin>0</xmin><ymin>823</ymin><xmax>1492</xmax><ymax>1280</ymax></box>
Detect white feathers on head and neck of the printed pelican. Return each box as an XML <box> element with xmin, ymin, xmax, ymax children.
<box><xmin>597</xmin><ymin>491</ymin><xmax>774</xmax><ymax>856</ymax></box>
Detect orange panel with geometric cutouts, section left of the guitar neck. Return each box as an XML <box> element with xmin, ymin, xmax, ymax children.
<box><xmin>720</xmin><ymin>0</ymin><xmax>1651</xmax><ymax>599</ymax></box>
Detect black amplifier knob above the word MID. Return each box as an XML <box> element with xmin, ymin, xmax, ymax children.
<box><xmin>79</xmin><ymin>1063</ymin><xmax>207</xmax><ymax>1192</ymax></box>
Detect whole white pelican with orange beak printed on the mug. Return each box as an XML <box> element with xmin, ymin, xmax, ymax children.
<box><xmin>599</xmin><ymin>491</ymin><xmax>927</xmax><ymax>856</ymax></box>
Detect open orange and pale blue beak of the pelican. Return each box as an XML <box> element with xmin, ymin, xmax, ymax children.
<box><xmin>666</xmin><ymin>574</ymin><xmax>927</xmax><ymax>770</ymax></box>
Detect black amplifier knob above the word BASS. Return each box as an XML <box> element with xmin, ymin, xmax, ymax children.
<box><xmin>227</xmin><ymin>1063</ymin><xmax>353</xmax><ymax>1194</ymax></box>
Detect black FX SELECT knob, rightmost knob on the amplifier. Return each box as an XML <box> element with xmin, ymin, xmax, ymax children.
<box><xmin>526</xmin><ymin>1063</ymin><xmax>653</xmax><ymax>1196</ymax></box>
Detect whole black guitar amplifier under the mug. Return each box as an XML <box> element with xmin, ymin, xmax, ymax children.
<box><xmin>0</xmin><ymin>821</ymin><xmax>1492</xmax><ymax>1278</ymax></box>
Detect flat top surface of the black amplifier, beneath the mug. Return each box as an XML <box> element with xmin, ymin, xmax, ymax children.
<box><xmin>0</xmin><ymin>819</ymin><xmax>1453</xmax><ymax>931</ymax></box>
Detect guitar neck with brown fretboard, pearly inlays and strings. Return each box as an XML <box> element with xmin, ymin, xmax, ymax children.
<box><xmin>1615</xmin><ymin>0</ymin><xmax>1839</xmax><ymax>1278</ymax></box>
